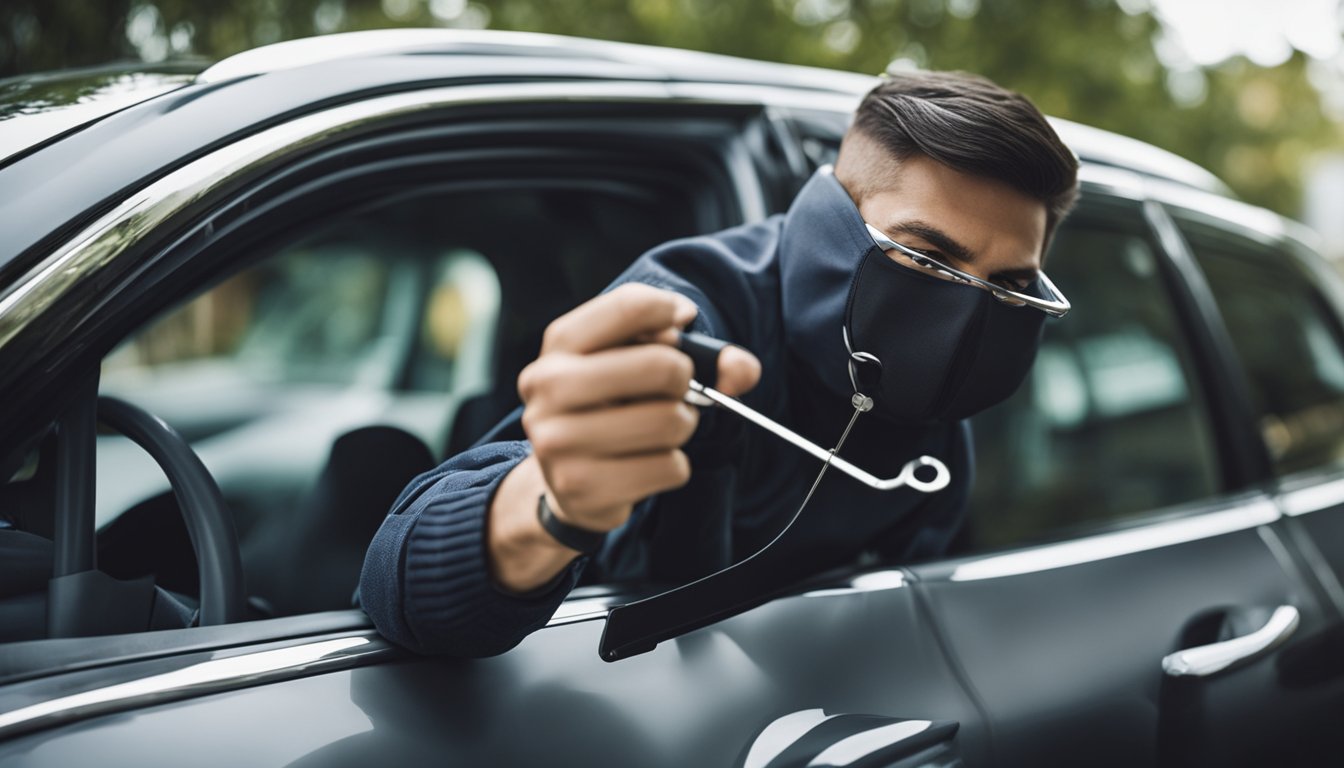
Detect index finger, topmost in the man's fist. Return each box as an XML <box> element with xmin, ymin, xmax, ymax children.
<box><xmin>542</xmin><ymin>282</ymin><xmax>696</xmax><ymax>355</ymax></box>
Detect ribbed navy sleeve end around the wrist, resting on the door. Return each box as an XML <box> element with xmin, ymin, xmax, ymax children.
<box><xmin>359</xmin><ymin>441</ymin><xmax>586</xmax><ymax>656</ymax></box>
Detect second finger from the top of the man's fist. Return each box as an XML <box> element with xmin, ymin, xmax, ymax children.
<box><xmin>517</xmin><ymin>344</ymin><xmax>692</xmax><ymax>414</ymax></box>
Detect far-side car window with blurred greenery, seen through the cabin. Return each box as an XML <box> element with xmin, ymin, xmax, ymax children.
<box><xmin>101</xmin><ymin>223</ymin><xmax>500</xmax><ymax>440</ymax></box>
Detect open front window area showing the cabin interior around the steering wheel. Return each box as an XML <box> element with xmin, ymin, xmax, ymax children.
<box><xmin>85</xmin><ymin>180</ymin><xmax>703</xmax><ymax>617</ymax></box>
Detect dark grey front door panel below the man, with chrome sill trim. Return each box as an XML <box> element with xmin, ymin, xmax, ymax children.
<box><xmin>0</xmin><ymin>572</ymin><xmax>986</xmax><ymax>768</ymax></box>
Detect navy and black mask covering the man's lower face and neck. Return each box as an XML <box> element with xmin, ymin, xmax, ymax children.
<box><xmin>780</xmin><ymin>168</ymin><xmax>1046</xmax><ymax>424</ymax></box>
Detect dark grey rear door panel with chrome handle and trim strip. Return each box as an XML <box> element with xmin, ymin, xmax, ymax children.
<box><xmin>913</xmin><ymin>498</ymin><xmax>1328</xmax><ymax>765</ymax></box>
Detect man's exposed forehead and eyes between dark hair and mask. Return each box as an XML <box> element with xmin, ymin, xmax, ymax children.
<box><xmin>859</xmin><ymin>155</ymin><xmax>1046</xmax><ymax>289</ymax></box>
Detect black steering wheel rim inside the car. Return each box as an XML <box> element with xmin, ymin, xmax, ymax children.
<box><xmin>98</xmin><ymin>395</ymin><xmax>246</xmax><ymax>627</ymax></box>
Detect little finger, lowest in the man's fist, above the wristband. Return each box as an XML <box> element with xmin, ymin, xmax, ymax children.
<box><xmin>542</xmin><ymin>451</ymin><xmax>691</xmax><ymax>521</ymax></box>
